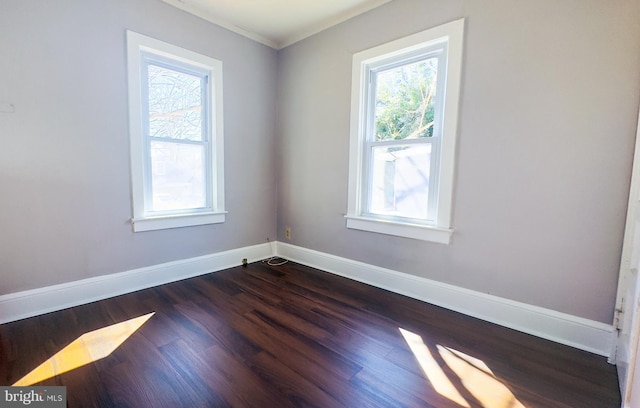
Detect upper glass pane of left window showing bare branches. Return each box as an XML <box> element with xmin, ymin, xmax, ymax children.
<box><xmin>148</xmin><ymin>65</ymin><xmax>202</xmax><ymax>140</ymax></box>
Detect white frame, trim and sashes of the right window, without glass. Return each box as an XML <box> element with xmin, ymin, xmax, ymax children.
<box><xmin>346</xmin><ymin>19</ymin><xmax>464</xmax><ymax>244</ymax></box>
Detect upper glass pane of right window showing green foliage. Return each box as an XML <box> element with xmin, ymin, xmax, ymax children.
<box><xmin>374</xmin><ymin>57</ymin><xmax>438</xmax><ymax>141</ymax></box>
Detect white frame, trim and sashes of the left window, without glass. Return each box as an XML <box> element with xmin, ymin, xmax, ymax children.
<box><xmin>127</xmin><ymin>30</ymin><xmax>226</xmax><ymax>232</ymax></box>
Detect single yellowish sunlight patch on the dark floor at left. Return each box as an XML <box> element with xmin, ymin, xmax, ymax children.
<box><xmin>13</xmin><ymin>312</ymin><xmax>155</xmax><ymax>386</ymax></box>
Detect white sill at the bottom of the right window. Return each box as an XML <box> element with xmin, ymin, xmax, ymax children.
<box><xmin>346</xmin><ymin>215</ymin><xmax>453</xmax><ymax>245</ymax></box>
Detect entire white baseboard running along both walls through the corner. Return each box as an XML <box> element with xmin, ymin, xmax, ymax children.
<box><xmin>0</xmin><ymin>242</ymin><xmax>615</xmax><ymax>358</ymax></box>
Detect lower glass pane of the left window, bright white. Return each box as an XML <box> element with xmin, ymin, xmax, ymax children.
<box><xmin>151</xmin><ymin>142</ymin><xmax>206</xmax><ymax>211</ymax></box>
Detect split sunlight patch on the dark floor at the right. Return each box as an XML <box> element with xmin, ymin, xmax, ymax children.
<box><xmin>400</xmin><ymin>328</ymin><xmax>525</xmax><ymax>408</ymax></box>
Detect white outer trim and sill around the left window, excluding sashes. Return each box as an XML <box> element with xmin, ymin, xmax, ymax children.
<box><xmin>127</xmin><ymin>31</ymin><xmax>226</xmax><ymax>232</ymax></box>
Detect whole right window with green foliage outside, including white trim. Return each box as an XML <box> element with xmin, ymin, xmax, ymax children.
<box><xmin>347</xmin><ymin>20</ymin><xmax>464</xmax><ymax>244</ymax></box>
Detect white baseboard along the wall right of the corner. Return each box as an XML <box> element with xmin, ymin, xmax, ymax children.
<box><xmin>276</xmin><ymin>242</ymin><xmax>615</xmax><ymax>358</ymax></box>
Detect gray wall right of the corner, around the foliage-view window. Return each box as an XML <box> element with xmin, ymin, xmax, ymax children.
<box><xmin>277</xmin><ymin>0</ymin><xmax>640</xmax><ymax>323</ymax></box>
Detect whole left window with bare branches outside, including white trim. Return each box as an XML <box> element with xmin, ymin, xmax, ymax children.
<box><xmin>127</xmin><ymin>31</ymin><xmax>225</xmax><ymax>231</ymax></box>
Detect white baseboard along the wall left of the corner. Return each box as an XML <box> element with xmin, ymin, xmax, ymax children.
<box><xmin>0</xmin><ymin>244</ymin><xmax>273</xmax><ymax>324</ymax></box>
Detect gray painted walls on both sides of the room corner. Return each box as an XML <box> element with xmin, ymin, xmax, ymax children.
<box><xmin>0</xmin><ymin>0</ymin><xmax>640</xmax><ymax>323</ymax></box>
